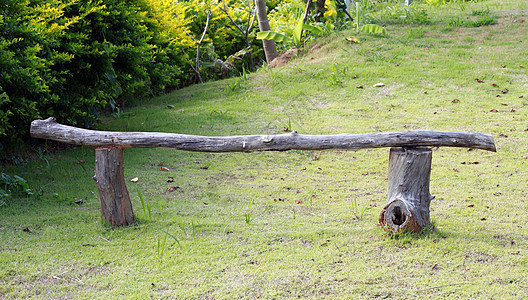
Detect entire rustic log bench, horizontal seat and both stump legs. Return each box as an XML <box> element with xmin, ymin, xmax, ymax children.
<box><xmin>30</xmin><ymin>118</ymin><xmax>496</xmax><ymax>232</ymax></box>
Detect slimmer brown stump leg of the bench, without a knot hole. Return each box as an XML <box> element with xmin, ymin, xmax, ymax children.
<box><xmin>93</xmin><ymin>147</ymin><xmax>134</xmax><ymax>226</ymax></box>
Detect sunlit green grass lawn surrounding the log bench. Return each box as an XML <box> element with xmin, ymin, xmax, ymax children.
<box><xmin>0</xmin><ymin>0</ymin><xmax>528</xmax><ymax>299</ymax></box>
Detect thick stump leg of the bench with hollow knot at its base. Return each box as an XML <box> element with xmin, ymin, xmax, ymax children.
<box><xmin>379</xmin><ymin>148</ymin><xmax>434</xmax><ymax>232</ymax></box>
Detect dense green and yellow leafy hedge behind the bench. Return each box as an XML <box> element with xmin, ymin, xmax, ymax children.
<box><xmin>0</xmin><ymin>0</ymin><xmax>272</xmax><ymax>149</ymax></box>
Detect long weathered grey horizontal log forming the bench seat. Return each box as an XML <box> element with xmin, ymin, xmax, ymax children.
<box><xmin>30</xmin><ymin>118</ymin><xmax>496</xmax><ymax>152</ymax></box>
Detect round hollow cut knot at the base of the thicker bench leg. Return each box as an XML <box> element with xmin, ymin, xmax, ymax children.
<box><xmin>379</xmin><ymin>200</ymin><xmax>422</xmax><ymax>233</ymax></box>
